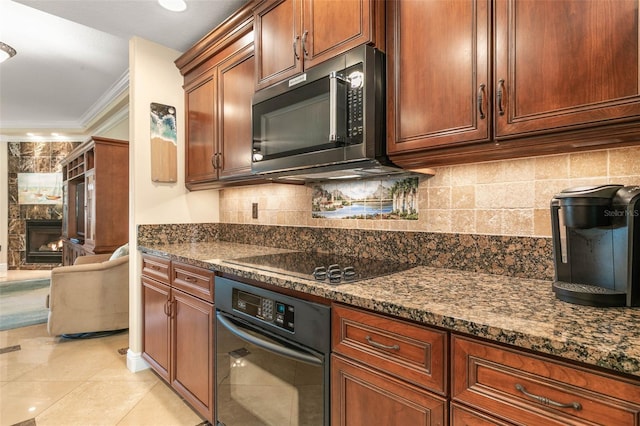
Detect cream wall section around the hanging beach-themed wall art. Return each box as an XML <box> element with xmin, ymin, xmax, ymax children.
<box><xmin>127</xmin><ymin>37</ymin><xmax>219</xmax><ymax>371</ymax></box>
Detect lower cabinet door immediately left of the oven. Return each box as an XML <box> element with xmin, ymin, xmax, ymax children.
<box><xmin>171</xmin><ymin>289</ymin><xmax>214</xmax><ymax>423</ymax></box>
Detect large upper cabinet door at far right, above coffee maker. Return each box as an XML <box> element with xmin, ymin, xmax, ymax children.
<box><xmin>494</xmin><ymin>0</ymin><xmax>640</xmax><ymax>137</ymax></box>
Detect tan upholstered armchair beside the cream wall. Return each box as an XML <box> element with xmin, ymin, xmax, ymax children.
<box><xmin>46</xmin><ymin>254</ymin><xmax>129</xmax><ymax>336</ymax></box>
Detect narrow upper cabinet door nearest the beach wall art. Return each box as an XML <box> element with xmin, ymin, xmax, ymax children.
<box><xmin>185</xmin><ymin>73</ymin><xmax>218</xmax><ymax>183</ymax></box>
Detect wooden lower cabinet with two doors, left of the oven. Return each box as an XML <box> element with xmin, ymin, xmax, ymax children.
<box><xmin>142</xmin><ymin>255</ymin><xmax>215</xmax><ymax>423</ymax></box>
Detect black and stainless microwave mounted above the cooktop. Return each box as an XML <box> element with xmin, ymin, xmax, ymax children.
<box><xmin>251</xmin><ymin>45</ymin><xmax>405</xmax><ymax>180</ymax></box>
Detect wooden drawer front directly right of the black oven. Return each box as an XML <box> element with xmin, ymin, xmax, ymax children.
<box><xmin>331</xmin><ymin>305</ymin><xmax>448</xmax><ymax>395</ymax></box>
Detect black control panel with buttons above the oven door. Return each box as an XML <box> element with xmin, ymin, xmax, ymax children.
<box><xmin>232</xmin><ymin>288</ymin><xmax>295</xmax><ymax>332</ymax></box>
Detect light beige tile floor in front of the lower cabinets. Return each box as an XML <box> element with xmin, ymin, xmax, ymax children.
<box><xmin>0</xmin><ymin>271</ymin><xmax>206</xmax><ymax>426</ymax></box>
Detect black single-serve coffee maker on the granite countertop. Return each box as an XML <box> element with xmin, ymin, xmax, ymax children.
<box><xmin>551</xmin><ymin>185</ymin><xmax>640</xmax><ymax>306</ymax></box>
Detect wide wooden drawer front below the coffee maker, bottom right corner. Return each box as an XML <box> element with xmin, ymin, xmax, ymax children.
<box><xmin>451</xmin><ymin>335</ymin><xmax>640</xmax><ymax>425</ymax></box>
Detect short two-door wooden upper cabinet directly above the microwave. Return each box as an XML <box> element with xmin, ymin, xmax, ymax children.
<box><xmin>254</xmin><ymin>0</ymin><xmax>384</xmax><ymax>89</ymax></box>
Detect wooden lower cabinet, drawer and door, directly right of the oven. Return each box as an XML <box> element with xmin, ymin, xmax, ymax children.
<box><xmin>331</xmin><ymin>304</ymin><xmax>448</xmax><ymax>426</ymax></box>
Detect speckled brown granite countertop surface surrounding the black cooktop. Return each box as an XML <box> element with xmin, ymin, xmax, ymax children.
<box><xmin>139</xmin><ymin>242</ymin><xmax>640</xmax><ymax>376</ymax></box>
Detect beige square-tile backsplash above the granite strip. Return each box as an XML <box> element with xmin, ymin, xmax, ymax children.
<box><xmin>220</xmin><ymin>147</ymin><xmax>640</xmax><ymax>237</ymax></box>
